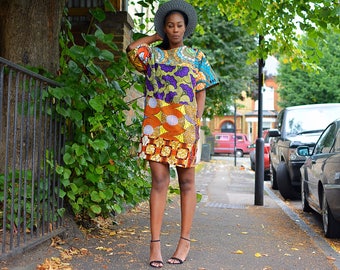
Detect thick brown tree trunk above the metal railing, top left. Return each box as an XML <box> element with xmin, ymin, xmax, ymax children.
<box><xmin>0</xmin><ymin>0</ymin><xmax>66</xmax><ymax>74</ymax></box>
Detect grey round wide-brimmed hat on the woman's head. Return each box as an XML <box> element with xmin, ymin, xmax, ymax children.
<box><xmin>154</xmin><ymin>0</ymin><xmax>197</xmax><ymax>38</ymax></box>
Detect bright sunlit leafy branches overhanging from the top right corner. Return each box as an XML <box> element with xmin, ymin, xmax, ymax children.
<box><xmin>190</xmin><ymin>0</ymin><xmax>340</xmax><ymax>68</ymax></box>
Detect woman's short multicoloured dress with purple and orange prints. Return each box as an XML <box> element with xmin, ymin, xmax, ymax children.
<box><xmin>128</xmin><ymin>44</ymin><xmax>218</xmax><ymax>168</ymax></box>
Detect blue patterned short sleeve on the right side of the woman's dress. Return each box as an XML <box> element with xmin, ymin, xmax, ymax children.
<box><xmin>195</xmin><ymin>50</ymin><xmax>219</xmax><ymax>92</ymax></box>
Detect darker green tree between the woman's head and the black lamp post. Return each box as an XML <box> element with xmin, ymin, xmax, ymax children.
<box><xmin>186</xmin><ymin>6</ymin><xmax>257</xmax><ymax>117</ymax></box>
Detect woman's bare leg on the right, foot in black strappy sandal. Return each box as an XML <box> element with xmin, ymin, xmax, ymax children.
<box><xmin>168</xmin><ymin>167</ymin><xmax>196</xmax><ymax>264</ymax></box>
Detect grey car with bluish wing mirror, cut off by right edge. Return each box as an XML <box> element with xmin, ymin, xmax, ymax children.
<box><xmin>297</xmin><ymin>119</ymin><xmax>340</xmax><ymax>238</ymax></box>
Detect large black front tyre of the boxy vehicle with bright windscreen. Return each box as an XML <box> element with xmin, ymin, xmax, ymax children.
<box><xmin>276</xmin><ymin>161</ymin><xmax>300</xmax><ymax>200</ymax></box>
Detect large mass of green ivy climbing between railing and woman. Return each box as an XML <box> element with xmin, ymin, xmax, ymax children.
<box><xmin>49</xmin><ymin>9</ymin><xmax>150</xmax><ymax>219</ymax></box>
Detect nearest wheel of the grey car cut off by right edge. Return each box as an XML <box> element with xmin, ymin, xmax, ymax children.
<box><xmin>321</xmin><ymin>192</ymin><xmax>340</xmax><ymax>238</ymax></box>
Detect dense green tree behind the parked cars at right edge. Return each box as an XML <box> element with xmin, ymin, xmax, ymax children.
<box><xmin>278</xmin><ymin>33</ymin><xmax>340</xmax><ymax>107</ymax></box>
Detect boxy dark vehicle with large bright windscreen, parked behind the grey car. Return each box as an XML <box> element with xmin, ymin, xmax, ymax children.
<box><xmin>269</xmin><ymin>103</ymin><xmax>340</xmax><ymax>199</ymax></box>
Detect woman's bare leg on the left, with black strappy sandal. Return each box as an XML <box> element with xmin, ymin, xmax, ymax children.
<box><xmin>149</xmin><ymin>161</ymin><xmax>170</xmax><ymax>267</ymax></box>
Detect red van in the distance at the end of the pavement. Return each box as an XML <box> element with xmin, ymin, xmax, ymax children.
<box><xmin>214</xmin><ymin>133</ymin><xmax>250</xmax><ymax>157</ymax></box>
